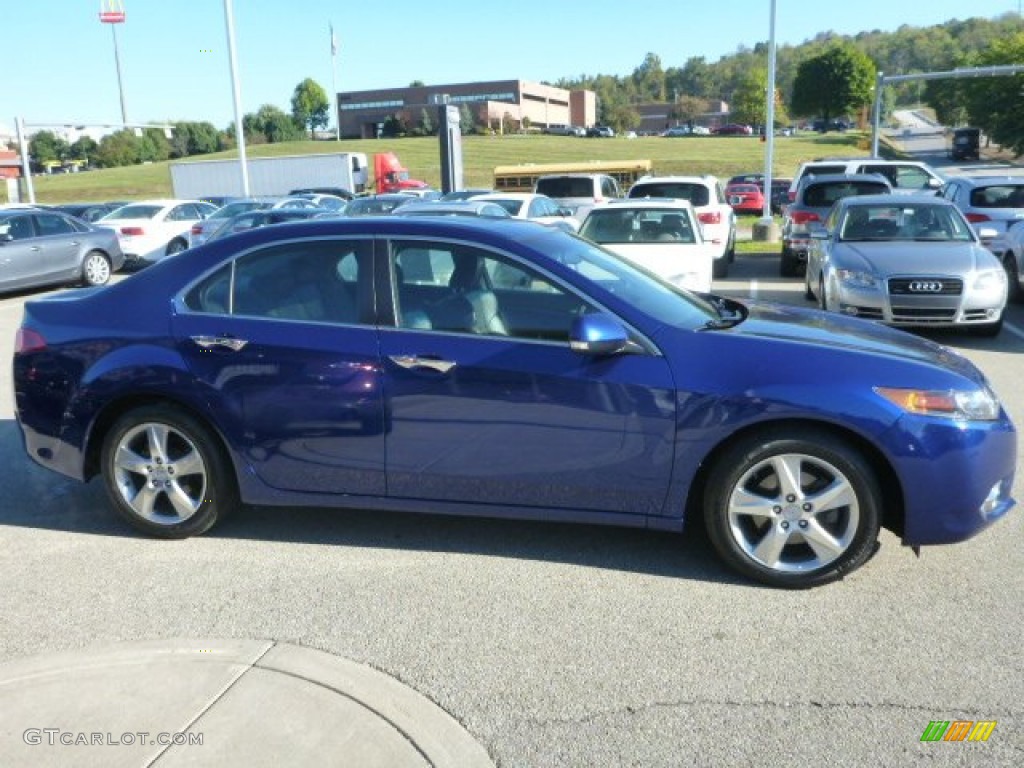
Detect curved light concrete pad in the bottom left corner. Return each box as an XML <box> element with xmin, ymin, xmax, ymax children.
<box><xmin>0</xmin><ymin>640</ymin><xmax>493</xmax><ymax>768</ymax></box>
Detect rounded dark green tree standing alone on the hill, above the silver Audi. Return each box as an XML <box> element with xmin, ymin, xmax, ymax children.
<box><xmin>792</xmin><ymin>43</ymin><xmax>876</xmax><ymax>121</ymax></box>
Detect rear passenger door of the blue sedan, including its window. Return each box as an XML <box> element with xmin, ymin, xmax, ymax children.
<box><xmin>173</xmin><ymin>238</ymin><xmax>387</xmax><ymax>496</ymax></box>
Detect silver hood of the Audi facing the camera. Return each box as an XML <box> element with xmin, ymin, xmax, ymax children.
<box><xmin>834</xmin><ymin>241</ymin><xmax>998</xmax><ymax>276</ymax></box>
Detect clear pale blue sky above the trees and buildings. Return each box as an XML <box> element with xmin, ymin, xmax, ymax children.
<box><xmin>0</xmin><ymin>0</ymin><xmax>1021</xmax><ymax>134</ymax></box>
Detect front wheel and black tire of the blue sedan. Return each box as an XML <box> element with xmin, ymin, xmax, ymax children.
<box><xmin>703</xmin><ymin>428</ymin><xmax>882</xmax><ymax>589</ymax></box>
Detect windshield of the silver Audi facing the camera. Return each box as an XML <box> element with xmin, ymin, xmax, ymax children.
<box><xmin>840</xmin><ymin>203</ymin><xmax>974</xmax><ymax>243</ymax></box>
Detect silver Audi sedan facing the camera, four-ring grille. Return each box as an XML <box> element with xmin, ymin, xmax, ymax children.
<box><xmin>804</xmin><ymin>195</ymin><xmax>1007</xmax><ymax>336</ymax></box>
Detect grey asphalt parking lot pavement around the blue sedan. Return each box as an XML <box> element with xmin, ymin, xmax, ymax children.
<box><xmin>0</xmin><ymin>231</ymin><xmax>1024</xmax><ymax>766</ymax></box>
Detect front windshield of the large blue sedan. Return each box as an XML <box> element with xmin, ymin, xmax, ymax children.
<box><xmin>524</xmin><ymin>229</ymin><xmax>721</xmax><ymax>329</ymax></box>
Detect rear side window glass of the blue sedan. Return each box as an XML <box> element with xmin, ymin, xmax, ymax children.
<box><xmin>184</xmin><ymin>240</ymin><xmax>373</xmax><ymax>324</ymax></box>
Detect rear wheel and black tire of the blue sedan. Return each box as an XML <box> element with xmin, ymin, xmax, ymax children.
<box><xmin>100</xmin><ymin>406</ymin><xmax>239</xmax><ymax>539</ymax></box>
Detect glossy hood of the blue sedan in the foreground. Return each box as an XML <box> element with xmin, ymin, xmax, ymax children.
<box><xmin>716</xmin><ymin>302</ymin><xmax>985</xmax><ymax>385</ymax></box>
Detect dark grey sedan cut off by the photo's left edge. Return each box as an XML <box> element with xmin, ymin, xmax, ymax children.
<box><xmin>0</xmin><ymin>208</ymin><xmax>124</xmax><ymax>292</ymax></box>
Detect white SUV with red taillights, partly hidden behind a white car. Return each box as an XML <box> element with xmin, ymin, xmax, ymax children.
<box><xmin>627</xmin><ymin>175</ymin><xmax>736</xmax><ymax>278</ymax></box>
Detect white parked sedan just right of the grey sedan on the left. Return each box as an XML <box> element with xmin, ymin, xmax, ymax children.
<box><xmin>96</xmin><ymin>200</ymin><xmax>217</xmax><ymax>267</ymax></box>
